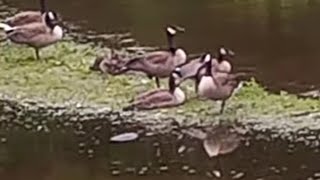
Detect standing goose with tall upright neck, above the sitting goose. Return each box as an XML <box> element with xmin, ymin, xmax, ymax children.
<box><xmin>122</xmin><ymin>26</ymin><xmax>187</xmax><ymax>88</ymax></box>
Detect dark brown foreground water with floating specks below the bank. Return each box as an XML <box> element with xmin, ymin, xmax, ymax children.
<box><xmin>0</xmin><ymin>121</ymin><xmax>320</xmax><ymax>180</ymax></box>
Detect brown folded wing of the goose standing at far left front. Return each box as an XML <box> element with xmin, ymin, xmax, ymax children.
<box><xmin>9</xmin><ymin>23</ymin><xmax>48</xmax><ymax>42</ymax></box>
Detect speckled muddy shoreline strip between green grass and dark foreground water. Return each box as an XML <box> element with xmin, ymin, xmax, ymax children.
<box><xmin>0</xmin><ymin>95</ymin><xmax>320</xmax><ymax>143</ymax></box>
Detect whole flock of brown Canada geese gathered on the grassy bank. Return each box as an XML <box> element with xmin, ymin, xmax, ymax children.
<box><xmin>0</xmin><ymin>0</ymin><xmax>249</xmax><ymax>113</ymax></box>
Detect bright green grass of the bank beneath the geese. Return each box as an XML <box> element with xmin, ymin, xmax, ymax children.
<box><xmin>0</xmin><ymin>42</ymin><xmax>320</xmax><ymax>119</ymax></box>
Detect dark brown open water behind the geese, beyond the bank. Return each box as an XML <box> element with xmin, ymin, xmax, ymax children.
<box><xmin>3</xmin><ymin>0</ymin><xmax>320</xmax><ymax>91</ymax></box>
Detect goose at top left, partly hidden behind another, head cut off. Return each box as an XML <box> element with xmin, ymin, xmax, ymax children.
<box><xmin>4</xmin><ymin>0</ymin><xmax>54</xmax><ymax>26</ymax></box>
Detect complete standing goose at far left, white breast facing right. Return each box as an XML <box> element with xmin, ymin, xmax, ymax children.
<box><xmin>0</xmin><ymin>12</ymin><xmax>63</xmax><ymax>59</ymax></box>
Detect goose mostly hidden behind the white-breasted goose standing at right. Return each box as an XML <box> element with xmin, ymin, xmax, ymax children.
<box><xmin>178</xmin><ymin>47</ymin><xmax>234</xmax><ymax>92</ymax></box>
